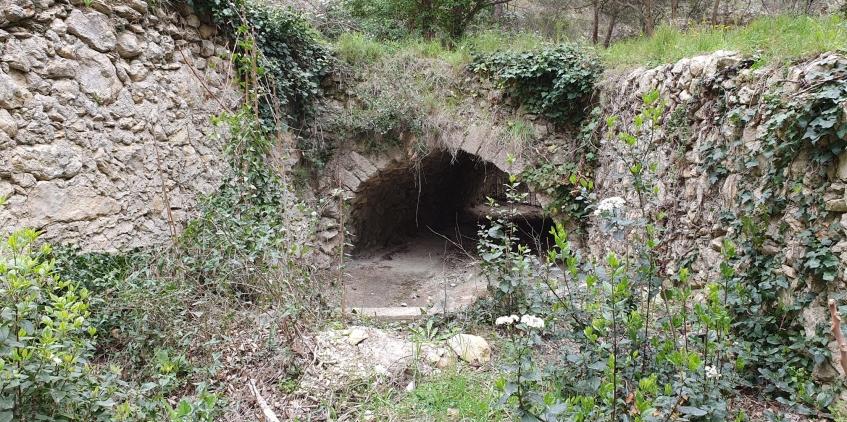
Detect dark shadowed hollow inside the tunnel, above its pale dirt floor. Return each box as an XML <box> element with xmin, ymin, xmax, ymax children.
<box><xmin>351</xmin><ymin>151</ymin><xmax>508</xmax><ymax>256</ymax></box>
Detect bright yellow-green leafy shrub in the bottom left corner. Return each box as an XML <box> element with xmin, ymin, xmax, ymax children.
<box><xmin>0</xmin><ymin>229</ymin><xmax>114</xmax><ymax>421</ymax></box>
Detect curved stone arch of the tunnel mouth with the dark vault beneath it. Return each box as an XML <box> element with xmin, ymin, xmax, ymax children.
<box><xmin>321</xmin><ymin>123</ymin><xmax>544</xmax><ymax>252</ymax></box>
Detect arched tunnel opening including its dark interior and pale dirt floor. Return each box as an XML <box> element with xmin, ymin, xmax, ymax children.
<box><xmin>345</xmin><ymin>151</ymin><xmax>553</xmax><ymax>318</ymax></box>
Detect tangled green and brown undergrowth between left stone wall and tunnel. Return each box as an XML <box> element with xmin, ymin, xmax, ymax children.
<box><xmin>48</xmin><ymin>107</ymin><xmax>323</xmax><ymax>421</ymax></box>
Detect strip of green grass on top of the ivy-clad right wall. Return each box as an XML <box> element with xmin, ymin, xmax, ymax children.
<box><xmin>601</xmin><ymin>16</ymin><xmax>847</xmax><ymax>68</ymax></box>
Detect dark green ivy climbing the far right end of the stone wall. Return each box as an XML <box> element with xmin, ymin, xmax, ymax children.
<box><xmin>703</xmin><ymin>55</ymin><xmax>847</xmax><ymax>413</ymax></box>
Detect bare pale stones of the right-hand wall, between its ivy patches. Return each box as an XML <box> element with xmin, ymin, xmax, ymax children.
<box><xmin>586</xmin><ymin>52</ymin><xmax>847</xmax><ymax>378</ymax></box>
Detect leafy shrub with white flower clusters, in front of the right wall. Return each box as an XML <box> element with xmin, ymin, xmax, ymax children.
<box><xmin>480</xmin><ymin>92</ymin><xmax>744</xmax><ymax>421</ymax></box>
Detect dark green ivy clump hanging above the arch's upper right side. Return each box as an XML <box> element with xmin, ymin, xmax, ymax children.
<box><xmin>470</xmin><ymin>44</ymin><xmax>601</xmax><ymax>122</ymax></box>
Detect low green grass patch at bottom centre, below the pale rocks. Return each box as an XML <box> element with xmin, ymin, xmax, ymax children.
<box><xmin>374</xmin><ymin>368</ymin><xmax>509</xmax><ymax>421</ymax></box>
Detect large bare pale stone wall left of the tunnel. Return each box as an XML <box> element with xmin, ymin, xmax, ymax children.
<box><xmin>0</xmin><ymin>0</ymin><xmax>239</xmax><ymax>250</ymax></box>
